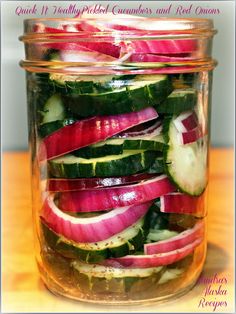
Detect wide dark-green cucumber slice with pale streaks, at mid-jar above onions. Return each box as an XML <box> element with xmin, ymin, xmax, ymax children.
<box><xmin>48</xmin><ymin>150</ymin><xmax>157</xmax><ymax>178</ymax></box>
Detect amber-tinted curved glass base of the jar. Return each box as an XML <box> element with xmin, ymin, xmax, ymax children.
<box><xmin>38</xmin><ymin>244</ymin><xmax>206</xmax><ymax>305</ymax></box>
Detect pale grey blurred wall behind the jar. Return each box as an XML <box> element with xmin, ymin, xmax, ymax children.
<box><xmin>1</xmin><ymin>1</ymin><xmax>235</xmax><ymax>150</ymax></box>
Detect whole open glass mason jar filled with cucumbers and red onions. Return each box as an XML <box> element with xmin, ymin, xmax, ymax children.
<box><xmin>20</xmin><ymin>17</ymin><xmax>216</xmax><ymax>304</ymax></box>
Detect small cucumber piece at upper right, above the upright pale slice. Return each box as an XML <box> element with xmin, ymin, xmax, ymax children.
<box><xmin>156</xmin><ymin>88</ymin><xmax>197</xmax><ymax>114</ymax></box>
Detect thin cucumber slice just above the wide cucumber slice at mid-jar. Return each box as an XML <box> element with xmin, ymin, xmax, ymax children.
<box><xmin>73</xmin><ymin>135</ymin><xmax>166</xmax><ymax>158</ymax></box>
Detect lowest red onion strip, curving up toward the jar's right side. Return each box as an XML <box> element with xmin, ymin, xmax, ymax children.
<box><xmin>101</xmin><ymin>238</ymin><xmax>203</xmax><ymax>268</ymax></box>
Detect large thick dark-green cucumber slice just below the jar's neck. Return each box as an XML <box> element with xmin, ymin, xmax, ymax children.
<box><xmin>63</xmin><ymin>75</ymin><xmax>172</xmax><ymax>117</ymax></box>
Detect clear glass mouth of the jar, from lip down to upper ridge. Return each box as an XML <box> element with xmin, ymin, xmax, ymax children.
<box><xmin>19</xmin><ymin>16</ymin><xmax>217</xmax><ymax>42</ymax></box>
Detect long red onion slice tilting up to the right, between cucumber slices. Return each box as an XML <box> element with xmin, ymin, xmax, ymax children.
<box><xmin>38</xmin><ymin>107</ymin><xmax>158</xmax><ymax>161</ymax></box>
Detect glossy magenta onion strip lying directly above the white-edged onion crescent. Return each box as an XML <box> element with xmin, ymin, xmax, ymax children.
<box><xmin>59</xmin><ymin>175</ymin><xmax>176</xmax><ymax>212</ymax></box>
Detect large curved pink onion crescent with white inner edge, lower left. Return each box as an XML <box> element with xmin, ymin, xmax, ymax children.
<box><xmin>42</xmin><ymin>194</ymin><xmax>151</xmax><ymax>242</ymax></box>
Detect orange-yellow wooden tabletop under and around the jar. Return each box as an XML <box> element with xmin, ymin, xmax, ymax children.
<box><xmin>2</xmin><ymin>149</ymin><xmax>234</xmax><ymax>313</ymax></box>
